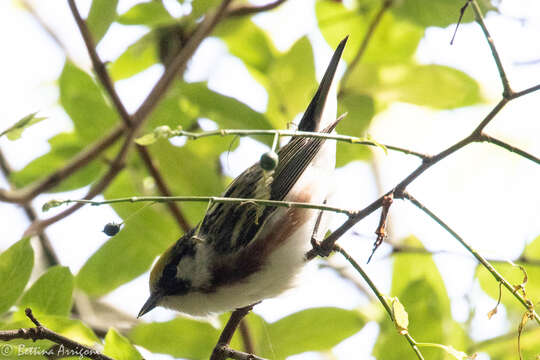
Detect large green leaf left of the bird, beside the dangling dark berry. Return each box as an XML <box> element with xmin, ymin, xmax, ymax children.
<box><xmin>76</xmin><ymin>172</ymin><xmax>179</xmax><ymax>299</ymax></box>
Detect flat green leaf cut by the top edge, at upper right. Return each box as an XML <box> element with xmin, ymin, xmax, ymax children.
<box><xmin>391</xmin><ymin>0</ymin><xmax>496</xmax><ymax>28</ymax></box>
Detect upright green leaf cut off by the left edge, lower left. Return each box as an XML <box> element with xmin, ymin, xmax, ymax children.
<box><xmin>0</xmin><ymin>238</ymin><xmax>34</xmax><ymax>314</ymax></box>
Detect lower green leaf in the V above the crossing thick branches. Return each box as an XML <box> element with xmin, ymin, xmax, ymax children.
<box><xmin>109</xmin><ymin>31</ymin><xmax>159</xmax><ymax>81</ymax></box>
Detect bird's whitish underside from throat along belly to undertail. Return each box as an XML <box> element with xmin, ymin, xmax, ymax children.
<box><xmin>160</xmin><ymin>141</ymin><xmax>335</xmax><ymax>316</ymax></box>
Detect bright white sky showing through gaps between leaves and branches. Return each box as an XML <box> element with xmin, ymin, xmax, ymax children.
<box><xmin>0</xmin><ymin>0</ymin><xmax>540</xmax><ymax>359</ymax></box>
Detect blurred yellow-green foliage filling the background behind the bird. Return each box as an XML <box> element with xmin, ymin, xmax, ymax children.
<box><xmin>0</xmin><ymin>0</ymin><xmax>540</xmax><ymax>360</ymax></box>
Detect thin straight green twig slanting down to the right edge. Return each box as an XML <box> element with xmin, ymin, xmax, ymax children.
<box><xmin>396</xmin><ymin>192</ymin><xmax>540</xmax><ymax>324</ymax></box>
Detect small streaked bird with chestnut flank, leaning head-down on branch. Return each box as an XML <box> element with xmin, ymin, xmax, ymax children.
<box><xmin>138</xmin><ymin>37</ymin><xmax>348</xmax><ymax>317</ymax></box>
